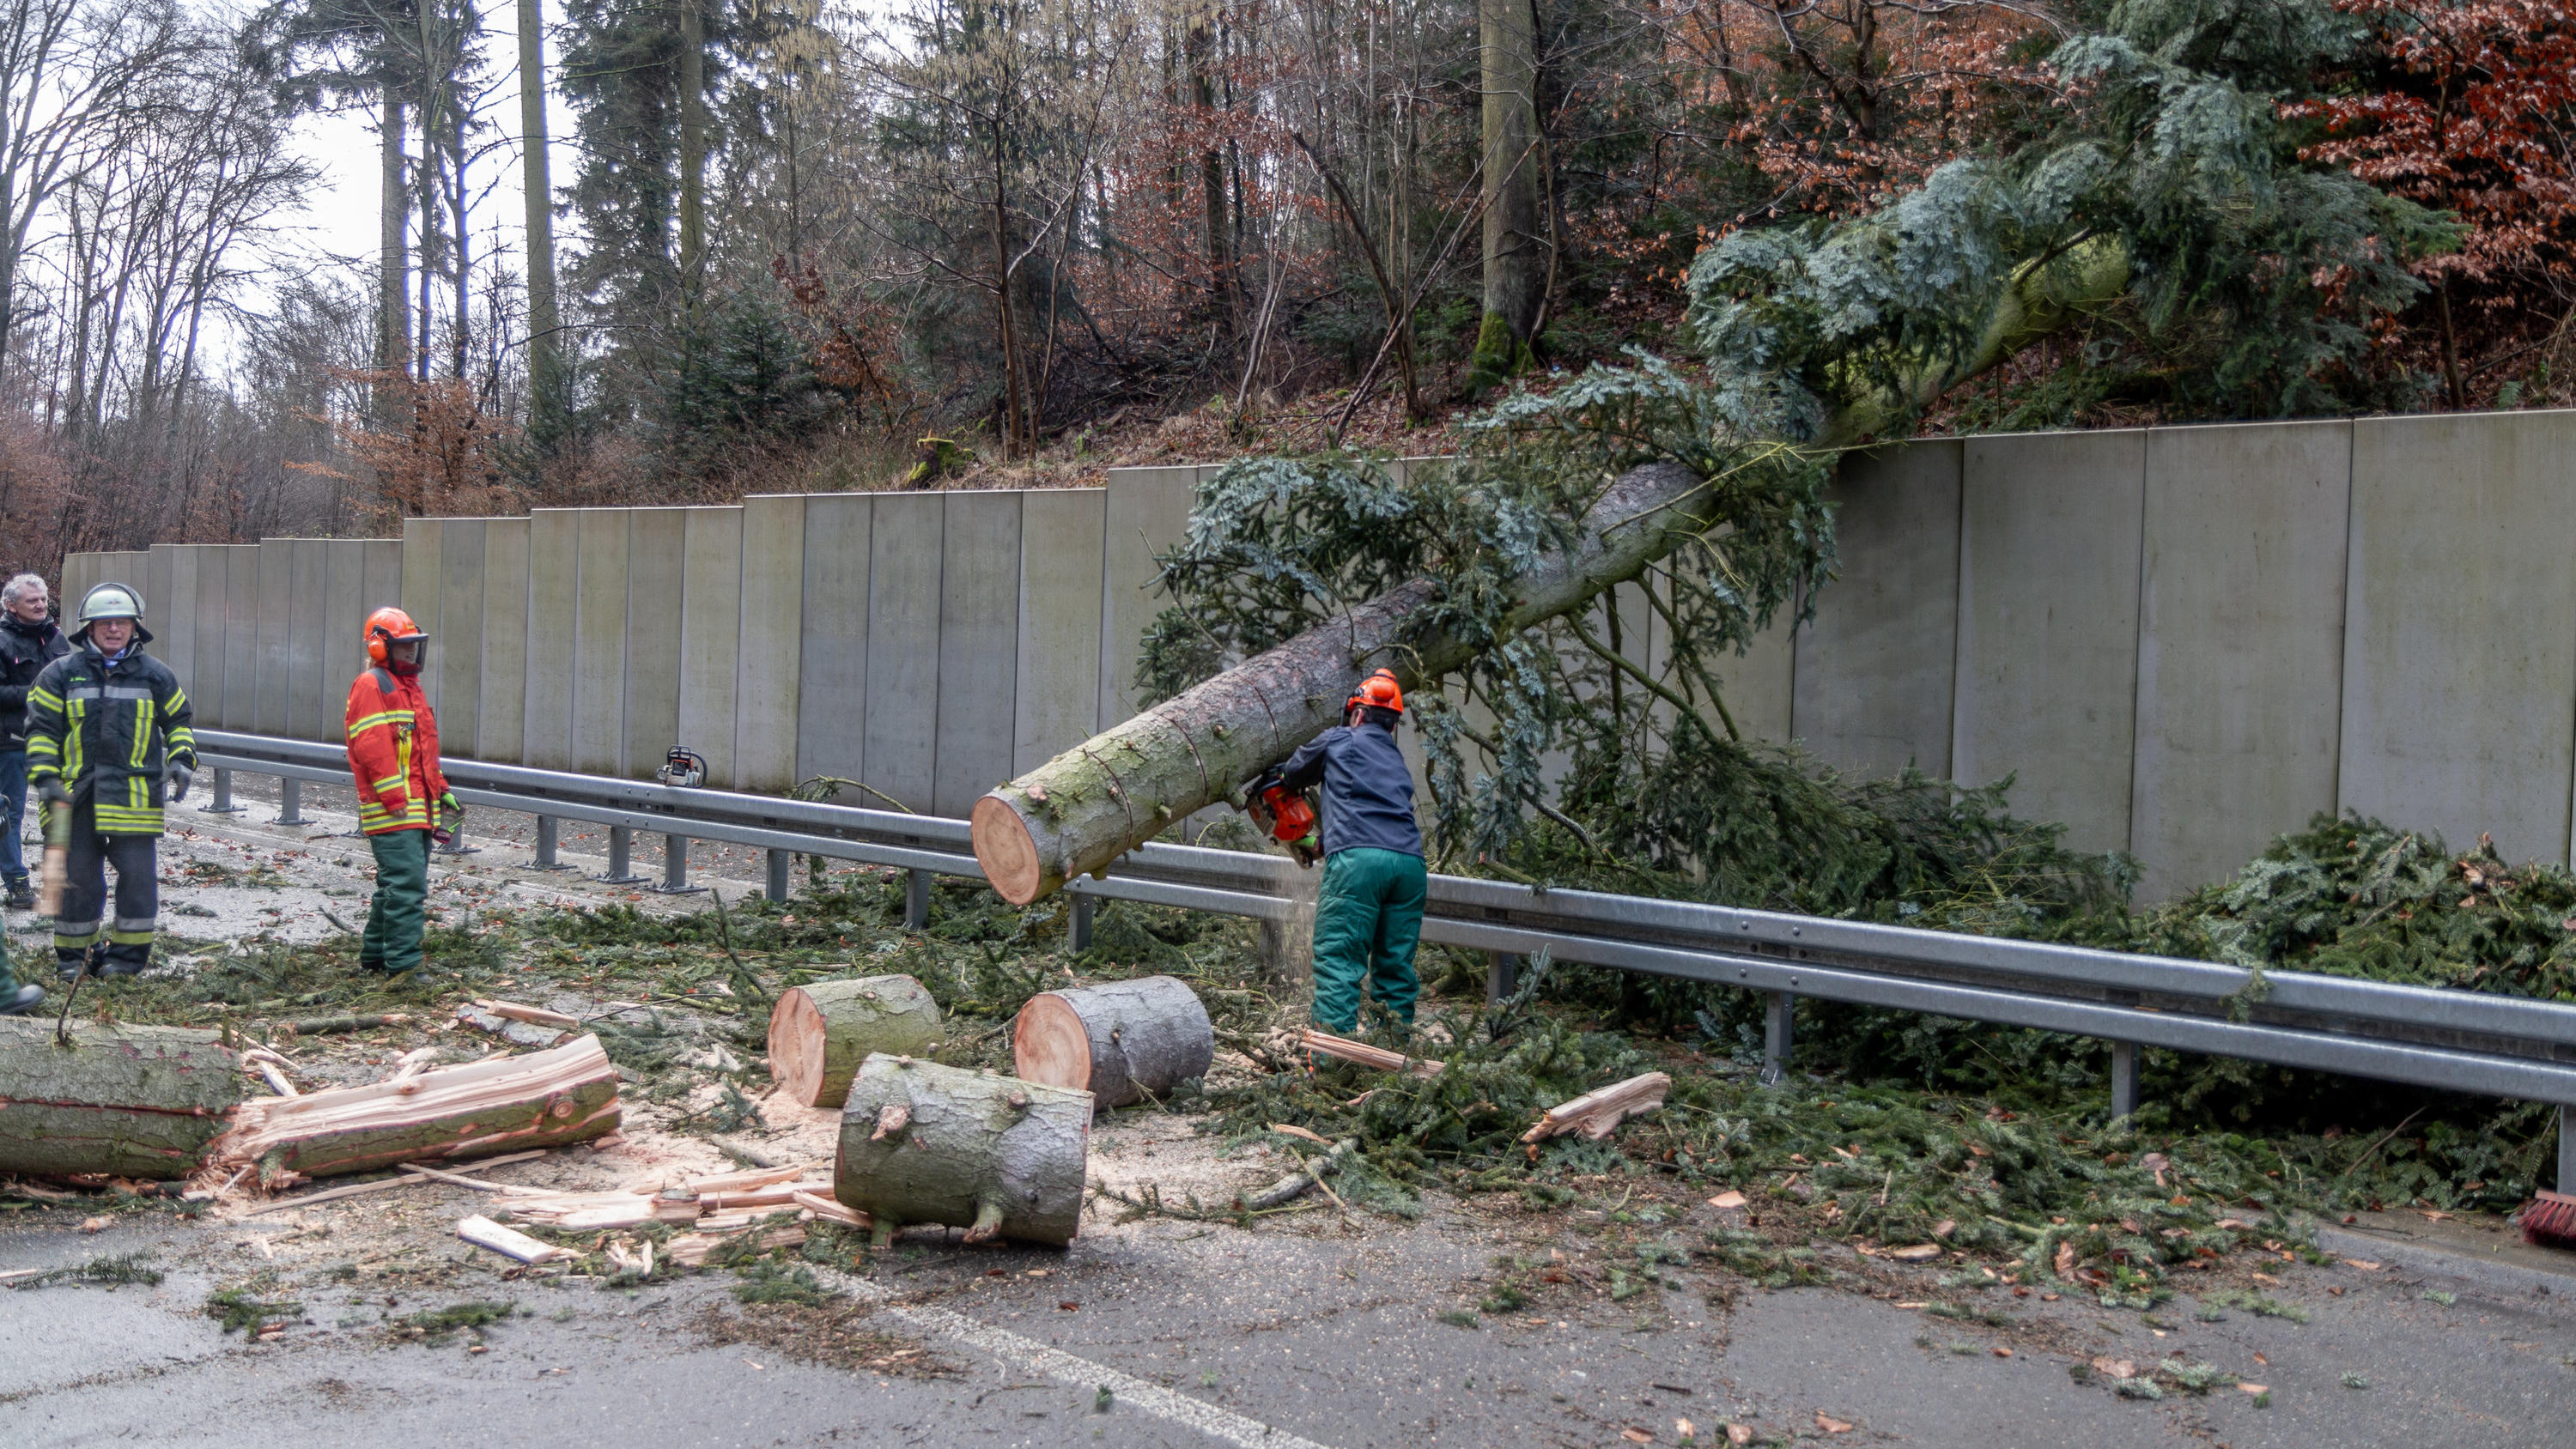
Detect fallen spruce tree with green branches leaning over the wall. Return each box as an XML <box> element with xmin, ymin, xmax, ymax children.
<box><xmin>974</xmin><ymin>8</ymin><xmax>2452</xmax><ymax>903</ymax></box>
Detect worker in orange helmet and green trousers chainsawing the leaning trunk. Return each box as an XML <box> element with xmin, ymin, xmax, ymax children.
<box><xmin>1278</xmin><ymin>670</ymin><xmax>1430</xmax><ymax>1032</ymax></box>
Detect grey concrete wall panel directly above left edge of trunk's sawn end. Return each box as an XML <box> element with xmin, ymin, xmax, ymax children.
<box><xmin>933</xmin><ymin>492</ymin><xmax>1023</xmax><ymax>818</ymax></box>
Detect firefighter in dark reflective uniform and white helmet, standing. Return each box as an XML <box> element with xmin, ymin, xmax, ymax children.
<box><xmin>26</xmin><ymin>585</ymin><xmax>196</xmax><ymax>980</ymax></box>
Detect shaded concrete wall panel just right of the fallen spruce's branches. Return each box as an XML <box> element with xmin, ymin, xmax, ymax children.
<box><xmin>1793</xmin><ymin>438</ymin><xmax>1963</xmax><ymax>777</ymax></box>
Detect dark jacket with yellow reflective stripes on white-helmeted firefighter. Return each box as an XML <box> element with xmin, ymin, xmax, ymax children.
<box><xmin>26</xmin><ymin>644</ymin><xmax>196</xmax><ymax>836</ymax></box>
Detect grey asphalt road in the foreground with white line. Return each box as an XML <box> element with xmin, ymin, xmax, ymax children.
<box><xmin>0</xmin><ymin>1189</ymin><xmax>2576</xmax><ymax>1449</ymax></box>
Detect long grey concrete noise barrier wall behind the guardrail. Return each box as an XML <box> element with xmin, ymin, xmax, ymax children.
<box><xmin>62</xmin><ymin>412</ymin><xmax>2576</xmax><ymax>898</ymax></box>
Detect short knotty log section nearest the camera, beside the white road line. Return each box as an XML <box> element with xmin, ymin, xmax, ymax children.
<box><xmin>832</xmin><ymin>1052</ymin><xmax>1092</xmax><ymax>1248</ymax></box>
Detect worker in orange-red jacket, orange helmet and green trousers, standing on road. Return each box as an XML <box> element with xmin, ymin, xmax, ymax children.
<box><xmin>348</xmin><ymin>608</ymin><xmax>464</xmax><ymax>973</ymax></box>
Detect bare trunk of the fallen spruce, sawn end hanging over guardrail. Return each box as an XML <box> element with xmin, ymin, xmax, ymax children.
<box><xmin>974</xmin><ymin>239</ymin><xmax>2128</xmax><ymax>906</ymax></box>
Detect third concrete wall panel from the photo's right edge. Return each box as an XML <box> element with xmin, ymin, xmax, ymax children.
<box><xmin>1950</xmin><ymin>433</ymin><xmax>2146</xmax><ymax>849</ymax></box>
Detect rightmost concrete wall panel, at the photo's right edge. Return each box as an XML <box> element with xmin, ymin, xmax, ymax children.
<box><xmin>2336</xmin><ymin>412</ymin><xmax>2576</xmax><ymax>859</ymax></box>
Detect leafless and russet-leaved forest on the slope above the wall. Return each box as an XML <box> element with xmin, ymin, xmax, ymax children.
<box><xmin>0</xmin><ymin>0</ymin><xmax>2576</xmax><ymax>569</ymax></box>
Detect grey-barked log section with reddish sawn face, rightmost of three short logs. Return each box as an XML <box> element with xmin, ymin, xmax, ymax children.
<box><xmin>1010</xmin><ymin>975</ymin><xmax>1216</xmax><ymax>1106</ymax></box>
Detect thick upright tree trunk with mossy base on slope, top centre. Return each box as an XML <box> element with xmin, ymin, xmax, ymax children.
<box><xmin>1473</xmin><ymin>0</ymin><xmax>1548</xmax><ymax>386</ymax></box>
